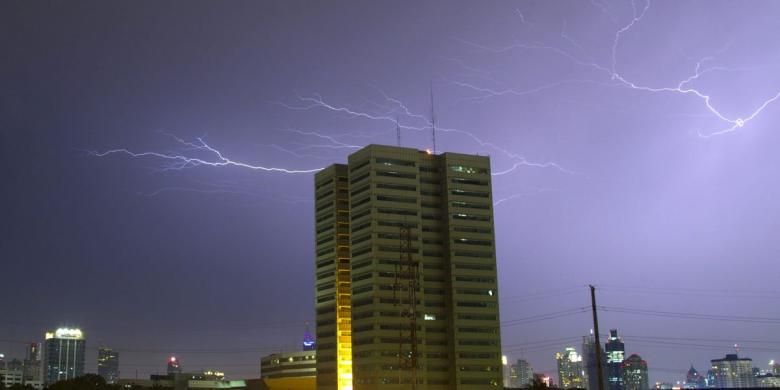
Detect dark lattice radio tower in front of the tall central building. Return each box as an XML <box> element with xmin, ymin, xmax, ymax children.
<box><xmin>393</xmin><ymin>224</ymin><xmax>420</xmax><ymax>390</ymax></box>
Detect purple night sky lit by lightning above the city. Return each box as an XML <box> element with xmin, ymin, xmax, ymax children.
<box><xmin>0</xmin><ymin>0</ymin><xmax>780</xmax><ymax>382</ymax></box>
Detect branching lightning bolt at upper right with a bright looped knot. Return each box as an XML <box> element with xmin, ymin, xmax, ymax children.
<box><xmin>455</xmin><ymin>0</ymin><xmax>780</xmax><ymax>138</ymax></box>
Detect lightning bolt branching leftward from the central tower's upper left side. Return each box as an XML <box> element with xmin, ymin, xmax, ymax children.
<box><xmin>89</xmin><ymin>134</ymin><xmax>322</xmax><ymax>174</ymax></box>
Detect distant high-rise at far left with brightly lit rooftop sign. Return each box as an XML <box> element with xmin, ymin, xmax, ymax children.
<box><xmin>43</xmin><ymin>328</ymin><xmax>86</xmax><ymax>386</ymax></box>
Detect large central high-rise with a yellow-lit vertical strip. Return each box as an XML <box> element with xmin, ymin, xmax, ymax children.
<box><xmin>315</xmin><ymin>145</ymin><xmax>502</xmax><ymax>390</ymax></box>
